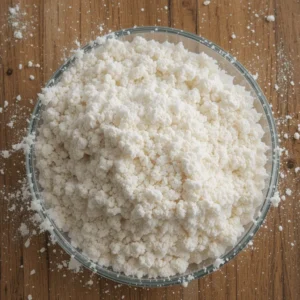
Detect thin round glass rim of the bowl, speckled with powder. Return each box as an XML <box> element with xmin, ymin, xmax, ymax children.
<box><xmin>25</xmin><ymin>26</ymin><xmax>279</xmax><ymax>287</ymax></box>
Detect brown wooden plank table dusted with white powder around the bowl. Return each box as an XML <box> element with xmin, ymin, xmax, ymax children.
<box><xmin>0</xmin><ymin>0</ymin><xmax>300</xmax><ymax>300</ymax></box>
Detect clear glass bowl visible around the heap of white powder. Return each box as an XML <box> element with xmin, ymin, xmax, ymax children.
<box><xmin>26</xmin><ymin>27</ymin><xmax>279</xmax><ymax>287</ymax></box>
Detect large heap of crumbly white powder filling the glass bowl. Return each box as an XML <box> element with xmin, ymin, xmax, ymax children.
<box><xmin>35</xmin><ymin>37</ymin><xmax>267</xmax><ymax>277</ymax></box>
